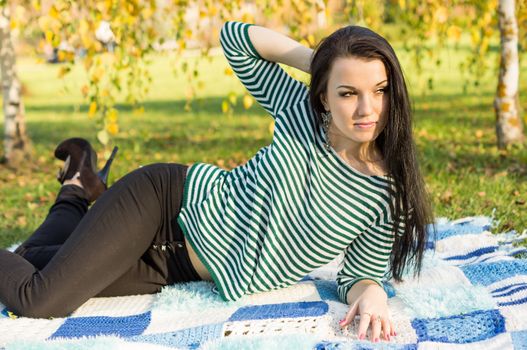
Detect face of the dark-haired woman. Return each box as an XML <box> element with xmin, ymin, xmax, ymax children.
<box><xmin>321</xmin><ymin>56</ymin><xmax>389</xmax><ymax>147</ymax></box>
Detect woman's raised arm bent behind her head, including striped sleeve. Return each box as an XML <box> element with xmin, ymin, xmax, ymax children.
<box><xmin>220</xmin><ymin>22</ymin><xmax>312</xmax><ymax>117</ymax></box>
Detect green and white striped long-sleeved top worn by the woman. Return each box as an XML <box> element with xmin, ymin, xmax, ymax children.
<box><xmin>178</xmin><ymin>22</ymin><xmax>400</xmax><ymax>303</ymax></box>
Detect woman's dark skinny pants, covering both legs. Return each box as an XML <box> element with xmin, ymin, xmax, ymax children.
<box><xmin>0</xmin><ymin>164</ymin><xmax>200</xmax><ymax>318</ymax></box>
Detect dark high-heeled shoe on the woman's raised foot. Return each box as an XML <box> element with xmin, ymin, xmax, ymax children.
<box><xmin>55</xmin><ymin>137</ymin><xmax>118</xmax><ymax>202</ymax></box>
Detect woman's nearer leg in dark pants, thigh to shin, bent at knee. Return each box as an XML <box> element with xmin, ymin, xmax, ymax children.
<box><xmin>0</xmin><ymin>164</ymin><xmax>190</xmax><ymax>317</ymax></box>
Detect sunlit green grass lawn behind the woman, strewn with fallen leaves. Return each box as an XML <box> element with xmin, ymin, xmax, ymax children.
<box><xmin>0</xmin><ymin>41</ymin><xmax>527</xmax><ymax>247</ymax></box>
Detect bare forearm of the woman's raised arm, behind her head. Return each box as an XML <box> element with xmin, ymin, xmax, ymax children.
<box><xmin>249</xmin><ymin>26</ymin><xmax>313</xmax><ymax>73</ymax></box>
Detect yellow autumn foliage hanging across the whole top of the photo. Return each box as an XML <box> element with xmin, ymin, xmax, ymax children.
<box><xmin>6</xmin><ymin>0</ymin><xmax>527</xmax><ymax>148</ymax></box>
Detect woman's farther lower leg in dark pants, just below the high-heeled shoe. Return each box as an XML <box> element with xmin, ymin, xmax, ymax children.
<box><xmin>15</xmin><ymin>185</ymin><xmax>89</xmax><ymax>270</ymax></box>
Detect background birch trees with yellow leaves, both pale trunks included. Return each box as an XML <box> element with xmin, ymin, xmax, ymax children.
<box><xmin>0</xmin><ymin>0</ymin><xmax>527</xmax><ymax>167</ymax></box>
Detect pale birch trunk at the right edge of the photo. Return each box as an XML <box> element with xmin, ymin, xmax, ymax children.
<box><xmin>494</xmin><ymin>0</ymin><xmax>525</xmax><ymax>149</ymax></box>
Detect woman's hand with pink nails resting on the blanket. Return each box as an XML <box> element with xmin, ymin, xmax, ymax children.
<box><xmin>339</xmin><ymin>280</ymin><xmax>396</xmax><ymax>342</ymax></box>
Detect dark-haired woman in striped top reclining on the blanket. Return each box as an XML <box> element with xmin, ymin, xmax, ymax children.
<box><xmin>0</xmin><ymin>22</ymin><xmax>432</xmax><ymax>341</ymax></box>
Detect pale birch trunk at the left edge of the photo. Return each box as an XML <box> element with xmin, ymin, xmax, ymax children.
<box><xmin>0</xmin><ymin>2</ymin><xmax>31</xmax><ymax>167</ymax></box>
